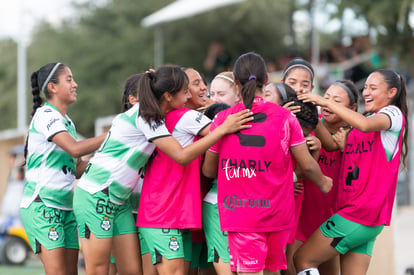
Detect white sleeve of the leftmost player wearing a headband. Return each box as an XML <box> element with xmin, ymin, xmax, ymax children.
<box><xmin>34</xmin><ymin>107</ymin><xmax>68</xmax><ymax>141</ymax></box>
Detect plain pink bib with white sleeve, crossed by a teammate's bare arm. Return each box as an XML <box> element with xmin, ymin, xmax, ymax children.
<box><xmin>137</xmin><ymin>109</ymin><xmax>210</xmax><ymax>229</ymax></box>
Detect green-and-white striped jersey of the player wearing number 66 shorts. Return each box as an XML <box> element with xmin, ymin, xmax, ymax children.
<box><xmin>78</xmin><ymin>104</ymin><xmax>171</xmax><ymax>204</ymax></box>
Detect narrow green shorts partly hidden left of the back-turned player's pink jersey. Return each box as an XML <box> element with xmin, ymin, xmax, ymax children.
<box><xmin>203</xmin><ymin>202</ymin><xmax>230</xmax><ymax>263</ymax></box>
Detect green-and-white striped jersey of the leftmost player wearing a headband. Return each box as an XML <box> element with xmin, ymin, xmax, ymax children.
<box><xmin>20</xmin><ymin>103</ymin><xmax>77</xmax><ymax>210</ymax></box>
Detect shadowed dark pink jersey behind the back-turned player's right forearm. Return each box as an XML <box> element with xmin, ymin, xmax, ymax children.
<box><xmin>296</xmin><ymin>148</ymin><xmax>342</xmax><ymax>242</ymax></box>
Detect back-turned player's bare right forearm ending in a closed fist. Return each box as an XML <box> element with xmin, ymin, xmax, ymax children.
<box><xmin>290</xmin><ymin>144</ymin><xmax>332</xmax><ymax>193</ymax></box>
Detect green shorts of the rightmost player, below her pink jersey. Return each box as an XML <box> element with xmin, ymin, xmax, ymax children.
<box><xmin>320</xmin><ymin>214</ymin><xmax>384</xmax><ymax>256</ymax></box>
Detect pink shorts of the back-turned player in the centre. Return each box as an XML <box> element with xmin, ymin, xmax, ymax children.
<box><xmin>228</xmin><ymin>230</ymin><xmax>290</xmax><ymax>272</ymax></box>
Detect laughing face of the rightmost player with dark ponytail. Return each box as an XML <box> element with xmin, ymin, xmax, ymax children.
<box><xmin>362</xmin><ymin>72</ymin><xmax>396</xmax><ymax>113</ymax></box>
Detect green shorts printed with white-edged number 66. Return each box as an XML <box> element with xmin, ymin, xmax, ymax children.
<box><xmin>73</xmin><ymin>188</ymin><xmax>137</xmax><ymax>238</ymax></box>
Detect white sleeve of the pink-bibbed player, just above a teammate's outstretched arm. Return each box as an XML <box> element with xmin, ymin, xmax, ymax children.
<box><xmin>174</xmin><ymin>110</ymin><xmax>211</xmax><ymax>136</ymax></box>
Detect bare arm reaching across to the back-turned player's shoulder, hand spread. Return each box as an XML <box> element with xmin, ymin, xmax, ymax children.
<box><xmin>153</xmin><ymin>110</ymin><xmax>253</xmax><ymax>165</ymax></box>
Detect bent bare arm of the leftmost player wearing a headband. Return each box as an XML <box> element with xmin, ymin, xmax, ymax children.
<box><xmin>52</xmin><ymin>132</ymin><xmax>106</xmax><ymax>158</ymax></box>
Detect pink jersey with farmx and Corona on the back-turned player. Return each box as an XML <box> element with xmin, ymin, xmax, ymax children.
<box><xmin>210</xmin><ymin>97</ymin><xmax>305</xmax><ymax>232</ymax></box>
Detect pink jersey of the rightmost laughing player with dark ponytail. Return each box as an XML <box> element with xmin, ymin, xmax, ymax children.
<box><xmin>338</xmin><ymin>109</ymin><xmax>404</xmax><ymax>226</ymax></box>
